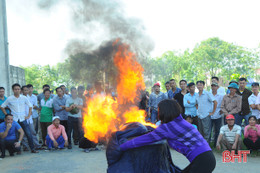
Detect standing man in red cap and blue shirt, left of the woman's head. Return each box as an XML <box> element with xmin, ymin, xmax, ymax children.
<box><xmin>148</xmin><ymin>83</ymin><xmax>166</xmax><ymax>123</ymax></box>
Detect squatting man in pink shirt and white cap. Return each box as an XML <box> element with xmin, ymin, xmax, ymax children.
<box><xmin>46</xmin><ymin>116</ymin><xmax>68</xmax><ymax>149</ymax></box>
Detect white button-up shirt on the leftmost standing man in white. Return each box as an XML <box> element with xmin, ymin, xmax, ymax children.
<box><xmin>1</xmin><ymin>95</ymin><xmax>32</xmax><ymax>122</ymax></box>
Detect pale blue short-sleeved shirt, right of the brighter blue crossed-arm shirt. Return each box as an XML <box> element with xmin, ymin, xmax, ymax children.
<box><xmin>196</xmin><ymin>90</ymin><xmax>216</xmax><ymax>119</ymax></box>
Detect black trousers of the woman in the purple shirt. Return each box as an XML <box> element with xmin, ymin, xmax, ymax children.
<box><xmin>182</xmin><ymin>151</ymin><xmax>216</xmax><ymax>173</ymax></box>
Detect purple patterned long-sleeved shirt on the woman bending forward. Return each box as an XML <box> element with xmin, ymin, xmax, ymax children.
<box><xmin>120</xmin><ymin>115</ymin><xmax>211</xmax><ymax>162</ymax></box>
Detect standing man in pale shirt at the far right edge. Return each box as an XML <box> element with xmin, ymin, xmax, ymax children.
<box><xmin>248</xmin><ymin>82</ymin><xmax>260</xmax><ymax>123</ymax></box>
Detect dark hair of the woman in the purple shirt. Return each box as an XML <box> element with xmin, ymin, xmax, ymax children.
<box><xmin>158</xmin><ymin>99</ymin><xmax>182</xmax><ymax>123</ymax></box>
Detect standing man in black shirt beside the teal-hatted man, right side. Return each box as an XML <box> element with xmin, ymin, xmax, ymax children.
<box><xmin>235</xmin><ymin>78</ymin><xmax>252</xmax><ymax>126</ymax></box>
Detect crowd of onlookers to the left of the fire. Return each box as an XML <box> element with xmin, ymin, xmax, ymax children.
<box><xmin>0</xmin><ymin>83</ymin><xmax>101</xmax><ymax>158</ymax></box>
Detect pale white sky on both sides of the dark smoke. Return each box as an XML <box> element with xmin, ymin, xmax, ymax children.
<box><xmin>6</xmin><ymin>0</ymin><xmax>260</xmax><ymax>66</ymax></box>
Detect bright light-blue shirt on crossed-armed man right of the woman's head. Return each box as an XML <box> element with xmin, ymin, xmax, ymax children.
<box><xmin>183</xmin><ymin>93</ymin><xmax>197</xmax><ymax>117</ymax></box>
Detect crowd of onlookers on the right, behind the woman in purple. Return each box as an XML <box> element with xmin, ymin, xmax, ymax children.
<box><xmin>141</xmin><ymin>77</ymin><xmax>260</xmax><ymax>155</ymax></box>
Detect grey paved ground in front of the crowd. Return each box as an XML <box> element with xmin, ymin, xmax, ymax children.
<box><xmin>0</xmin><ymin>147</ymin><xmax>260</xmax><ymax>173</ymax></box>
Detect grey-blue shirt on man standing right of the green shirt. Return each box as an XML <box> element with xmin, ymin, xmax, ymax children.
<box><xmin>53</xmin><ymin>95</ymin><xmax>68</xmax><ymax>120</ymax></box>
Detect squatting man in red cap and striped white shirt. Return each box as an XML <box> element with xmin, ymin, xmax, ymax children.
<box><xmin>216</xmin><ymin>114</ymin><xmax>242</xmax><ymax>151</ymax></box>
